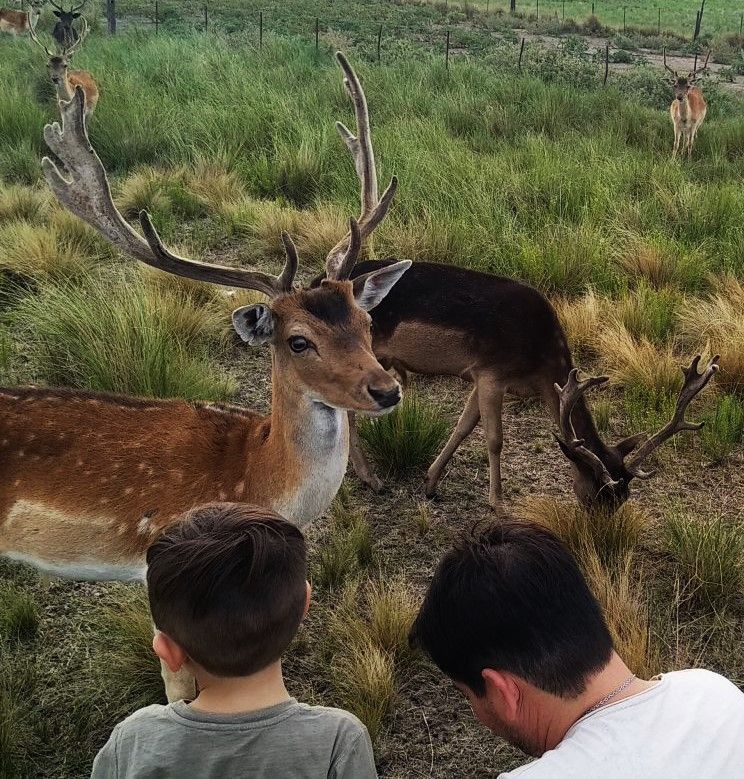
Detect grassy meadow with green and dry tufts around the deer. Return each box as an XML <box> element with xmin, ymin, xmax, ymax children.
<box><xmin>0</xmin><ymin>0</ymin><xmax>744</xmax><ymax>779</ymax></box>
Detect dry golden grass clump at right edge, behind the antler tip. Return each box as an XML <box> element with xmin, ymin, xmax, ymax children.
<box><xmin>680</xmin><ymin>274</ymin><xmax>744</xmax><ymax>393</ymax></box>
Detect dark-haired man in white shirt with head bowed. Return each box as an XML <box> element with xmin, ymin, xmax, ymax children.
<box><xmin>411</xmin><ymin>520</ymin><xmax>744</xmax><ymax>779</ymax></box>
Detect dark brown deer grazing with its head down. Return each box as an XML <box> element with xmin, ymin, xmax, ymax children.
<box><xmin>334</xmin><ymin>260</ymin><xmax>718</xmax><ymax>510</ymax></box>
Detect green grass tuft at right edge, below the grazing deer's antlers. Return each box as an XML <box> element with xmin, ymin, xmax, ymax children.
<box><xmin>665</xmin><ymin>507</ymin><xmax>744</xmax><ymax>609</ymax></box>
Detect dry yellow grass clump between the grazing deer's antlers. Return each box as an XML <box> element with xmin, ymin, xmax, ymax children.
<box><xmin>598</xmin><ymin>323</ymin><xmax>682</xmax><ymax>394</ymax></box>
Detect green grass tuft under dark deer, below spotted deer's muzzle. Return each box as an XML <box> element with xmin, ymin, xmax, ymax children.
<box><xmin>357</xmin><ymin>390</ymin><xmax>449</xmax><ymax>474</ymax></box>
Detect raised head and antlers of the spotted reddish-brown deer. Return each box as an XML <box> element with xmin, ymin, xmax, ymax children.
<box><xmin>42</xmin><ymin>55</ymin><xmax>411</xmax><ymax>414</ymax></box>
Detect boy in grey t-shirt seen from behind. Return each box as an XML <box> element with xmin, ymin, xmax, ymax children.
<box><xmin>92</xmin><ymin>503</ymin><xmax>377</xmax><ymax>779</ymax></box>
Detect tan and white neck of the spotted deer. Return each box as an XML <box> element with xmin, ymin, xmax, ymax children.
<box><xmin>266</xmin><ymin>358</ymin><xmax>349</xmax><ymax>525</ymax></box>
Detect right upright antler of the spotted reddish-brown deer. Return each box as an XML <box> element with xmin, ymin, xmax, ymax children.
<box><xmin>326</xmin><ymin>52</ymin><xmax>398</xmax><ymax>279</ymax></box>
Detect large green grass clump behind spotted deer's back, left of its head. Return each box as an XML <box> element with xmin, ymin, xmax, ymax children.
<box><xmin>13</xmin><ymin>273</ymin><xmax>234</xmax><ymax>400</ymax></box>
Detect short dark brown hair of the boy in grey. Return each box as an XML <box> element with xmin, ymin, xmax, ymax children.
<box><xmin>147</xmin><ymin>503</ymin><xmax>307</xmax><ymax>676</ymax></box>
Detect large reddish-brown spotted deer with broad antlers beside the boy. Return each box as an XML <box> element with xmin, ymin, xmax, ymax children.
<box><xmin>0</xmin><ymin>54</ymin><xmax>411</xmax><ymax>698</ymax></box>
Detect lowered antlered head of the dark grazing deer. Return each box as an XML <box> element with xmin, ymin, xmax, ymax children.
<box><xmin>555</xmin><ymin>355</ymin><xmax>719</xmax><ymax>512</ymax></box>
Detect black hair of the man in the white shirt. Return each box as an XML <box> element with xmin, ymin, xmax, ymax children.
<box><xmin>410</xmin><ymin>520</ymin><xmax>612</xmax><ymax>698</ymax></box>
